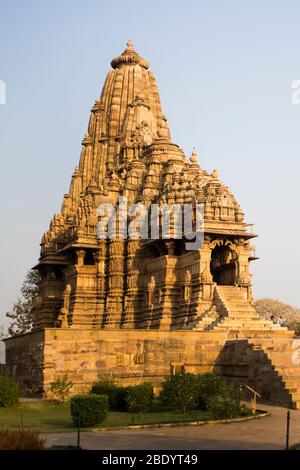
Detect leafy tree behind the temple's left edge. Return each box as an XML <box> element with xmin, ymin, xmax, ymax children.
<box><xmin>6</xmin><ymin>270</ymin><xmax>40</xmax><ymax>336</ymax></box>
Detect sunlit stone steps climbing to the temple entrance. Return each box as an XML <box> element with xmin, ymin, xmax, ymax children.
<box><xmin>213</xmin><ymin>286</ymin><xmax>300</xmax><ymax>409</ymax></box>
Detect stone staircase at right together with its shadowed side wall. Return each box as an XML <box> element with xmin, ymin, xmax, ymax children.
<box><xmin>187</xmin><ymin>286</ymin><xmax>300</xmax><ymax>409</ymax></box>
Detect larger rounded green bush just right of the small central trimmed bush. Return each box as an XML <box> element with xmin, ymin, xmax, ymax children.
<box><xmin>160</xmin><ymin>373</ymin><xmax>198</xmax><ymax>413</ymax></box>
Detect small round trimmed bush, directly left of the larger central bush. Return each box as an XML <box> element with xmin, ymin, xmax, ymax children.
<box><xmin>125</xmin><ymin>382</ymin><xmax>154</xmax><ymax>413</ymax></box>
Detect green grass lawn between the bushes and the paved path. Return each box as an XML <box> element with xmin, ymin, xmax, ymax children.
<box><xmin>0</xmin><ymin>402</ymin><xmax>216</xmax><ymax>432</ymax></box>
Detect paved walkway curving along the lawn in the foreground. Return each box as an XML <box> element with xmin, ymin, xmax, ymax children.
<box><xmin>44</xmin><ymin>405</ymin><xmax>300</xmax><ymax>450</ymax></box>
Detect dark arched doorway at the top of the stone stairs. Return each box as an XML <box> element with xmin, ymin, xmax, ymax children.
<box><xmin>210</xmin><ymin>245</ymin><xmax>236</xmax><ymax>286</ymax></box>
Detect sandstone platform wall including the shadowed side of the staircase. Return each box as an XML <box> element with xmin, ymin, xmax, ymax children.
<box><xmin>5</xmin><ymin>328</ymin><xmax>291</xmax><ymax>406</ymax></box>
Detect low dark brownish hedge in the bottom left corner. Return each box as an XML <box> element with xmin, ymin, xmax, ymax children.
<box><xmin>0</xmin><ymin>430</ymin><xmax>45</xmax><ymax>450</ymax></box>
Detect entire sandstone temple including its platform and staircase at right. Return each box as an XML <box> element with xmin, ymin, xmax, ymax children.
<box><xmin>6</xmin><ymin>41</ymin><xmax>300</xmax><ymax>407</ymax></box>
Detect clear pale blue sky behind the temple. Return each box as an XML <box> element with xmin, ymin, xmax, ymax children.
<box><xmin>0</xmin><ymin>0</ymin><xmax>300</xmax><ymax>330</ymax></box>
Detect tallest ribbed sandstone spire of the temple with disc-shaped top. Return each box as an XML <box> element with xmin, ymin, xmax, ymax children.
<box><xmin>56</xmin><ymin>41</ymin><xmax>169</xmax><ymax>223</ymax></box>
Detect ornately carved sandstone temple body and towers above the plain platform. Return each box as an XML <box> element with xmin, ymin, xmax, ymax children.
<box><xmin>34</xmin><ymin>42</ymin><xmax>255</xmax><ymax>328</ymax></box>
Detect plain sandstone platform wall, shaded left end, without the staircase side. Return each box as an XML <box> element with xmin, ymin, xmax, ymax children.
<box><xmin>6</xmin><ymin>328</ymin><xmax>226</xmax><ymax>397</ymax></box>
